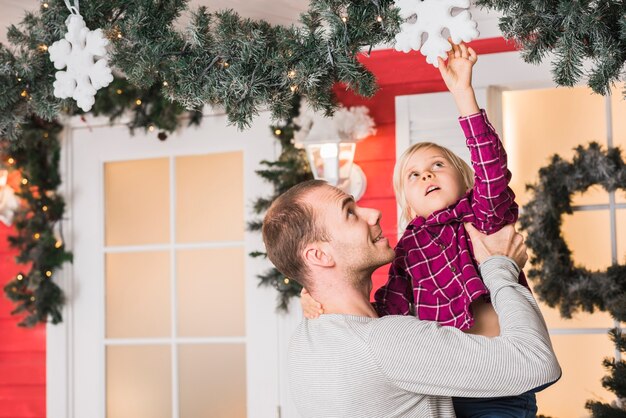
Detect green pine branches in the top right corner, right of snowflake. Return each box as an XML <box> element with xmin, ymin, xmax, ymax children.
<box><xmin>476</xmin><ymin>0</ymin><xmax>626</xmax><ymax>96</ymax></box>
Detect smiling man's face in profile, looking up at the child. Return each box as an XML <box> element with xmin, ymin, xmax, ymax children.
<box><xmin>309</xmin><ymin>186</ymin><xmax>394</xmax><ymax>280</ymax></box>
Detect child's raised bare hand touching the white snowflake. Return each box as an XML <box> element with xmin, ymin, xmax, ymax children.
<box><xmin>437</xmin><ymin>41</ymin><xmax>478</xmax><ymax>94</ymax></box>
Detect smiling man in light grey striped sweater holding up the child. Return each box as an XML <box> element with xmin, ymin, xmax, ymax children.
<box><xmin>263</xmin><ymin>180</ymin><xmax>560</xmax><ymax>418</ymax></box>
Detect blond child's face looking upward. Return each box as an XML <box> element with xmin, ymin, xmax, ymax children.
<box><xmin>402</xmin><ymin>147</ymin><xmax>466</xmax><ymax>218</ymax></box>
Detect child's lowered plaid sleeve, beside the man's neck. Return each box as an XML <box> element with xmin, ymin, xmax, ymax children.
<box><xmin>373</xmin><ymin>245</ymin><xmax>413</xmax><ymax>316</ymax></box>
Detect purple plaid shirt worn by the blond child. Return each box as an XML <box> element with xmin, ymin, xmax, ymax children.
<box><xmin>374</xmin><ymin>110</ymin><xmax>527</xmax><ymax>330</ymax></box>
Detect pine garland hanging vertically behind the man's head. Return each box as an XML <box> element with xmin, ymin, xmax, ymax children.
<box><xmin>248</xmin><ymin>96</ymin><xmax>313</xmax><ymax>311</ymax></box>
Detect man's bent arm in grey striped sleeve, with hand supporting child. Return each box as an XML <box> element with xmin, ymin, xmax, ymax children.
<box><xmin>369</xmin><ymin>227</ymin><xmax>561</xmax><ymax>397</ymax></box>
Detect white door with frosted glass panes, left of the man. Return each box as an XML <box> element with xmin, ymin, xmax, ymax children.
<box><xmin>48</xmin><ymin>109</ymin><xmax>279</xmax><ymax>418</ymax></box>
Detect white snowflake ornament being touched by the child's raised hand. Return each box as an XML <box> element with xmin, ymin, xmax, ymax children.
<box><xmin>395</xmin><ymin>0</ymin><xmax>478</xmax><ymax>67</ymax></box>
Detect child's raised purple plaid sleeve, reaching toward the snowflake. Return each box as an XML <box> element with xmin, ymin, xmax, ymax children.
<box><xmin>459</xmin><ymin>109</ymin><xmax>518</xmax><ymax>233</ymax></box>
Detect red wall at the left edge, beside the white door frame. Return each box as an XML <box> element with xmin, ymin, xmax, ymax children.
<box><xmin>0</xmin><ymin>223</ymin><xmax>46</xmax><ymax>418</ymax></box>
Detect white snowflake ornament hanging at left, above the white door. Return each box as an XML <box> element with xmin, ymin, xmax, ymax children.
<box><xmin>48</xmin><ymin>13</ymin><xmax>113</xmax><ymax>112</ymax></box>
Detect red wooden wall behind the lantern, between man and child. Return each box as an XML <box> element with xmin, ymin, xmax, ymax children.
<box><xmin>335</xmin><ymin>38</ymin><xmax>515</xmax><ymax>295</ymax></box>
